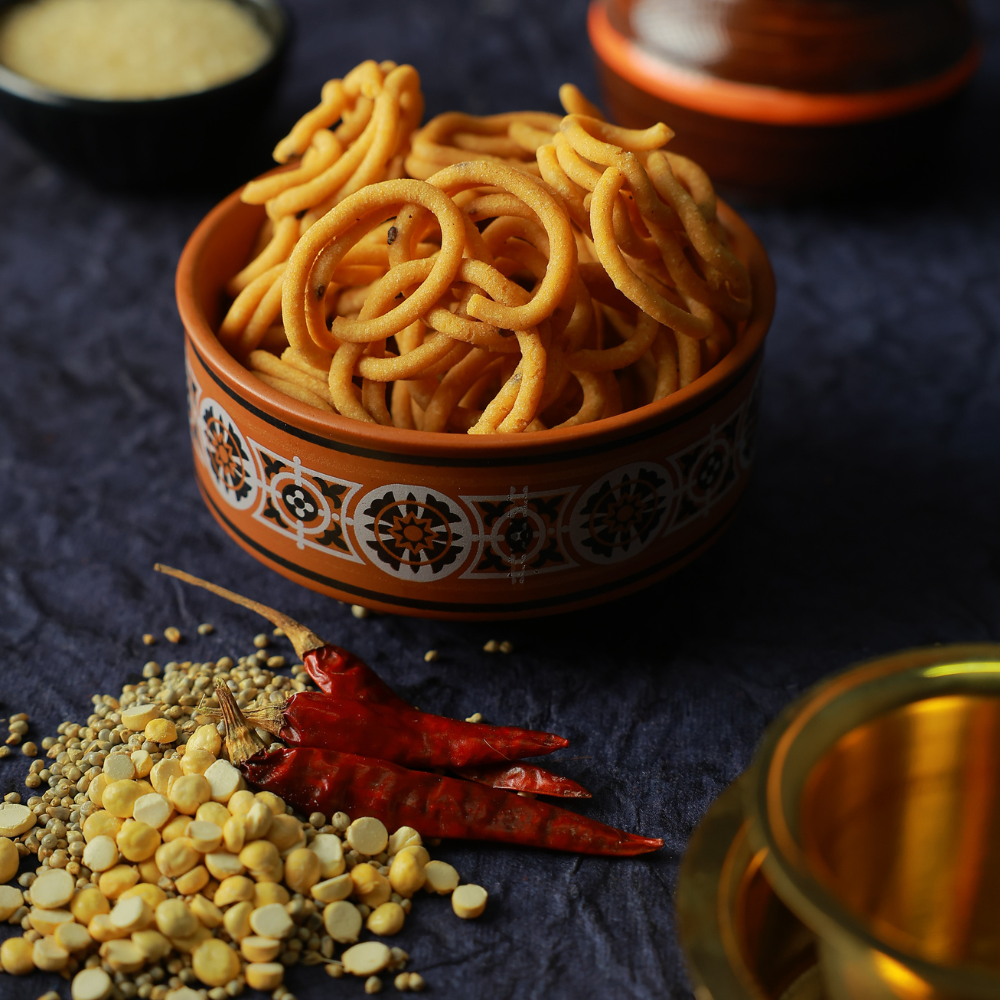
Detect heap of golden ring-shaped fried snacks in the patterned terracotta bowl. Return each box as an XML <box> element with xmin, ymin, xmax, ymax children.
<box><xmin>219</xmin><ymin>69</ymin><xmax>752</xmax><ymax>434</ymax></box>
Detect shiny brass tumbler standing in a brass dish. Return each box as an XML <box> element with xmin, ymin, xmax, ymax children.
<box><xmin>744</xmin><ymin>646</ymin><xmax>1000</xmax><ymax>1000</ymax></box>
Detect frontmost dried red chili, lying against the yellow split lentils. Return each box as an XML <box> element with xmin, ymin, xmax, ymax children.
<box><xmin>217</xmin><ymin>685</ymin><xmax>663</xmax><ymax>857</ymax></box>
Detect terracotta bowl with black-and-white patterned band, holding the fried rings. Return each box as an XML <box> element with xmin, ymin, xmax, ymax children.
<box><xmin>177</xmin><ymin>184</ymin><xmax>774</xmax><ymax>619</ymax></box>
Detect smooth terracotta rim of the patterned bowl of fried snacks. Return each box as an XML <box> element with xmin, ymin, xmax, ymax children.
<box><xmin>176</xmin><ymin>183</ymin><xmax>775</xmax><ymax>464</ymax></box>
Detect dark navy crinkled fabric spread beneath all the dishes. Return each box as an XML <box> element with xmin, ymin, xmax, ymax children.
<box><xmin>0</xmin><ymin>0</ymin><xmax>1000</xmax><ymax>1000</ymax></box>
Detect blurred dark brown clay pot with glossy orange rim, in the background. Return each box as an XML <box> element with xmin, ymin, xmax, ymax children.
<box><xmin>588</xmin><ymin>0</ymin><xmax>980</xmax><ymax>198</ymax></box>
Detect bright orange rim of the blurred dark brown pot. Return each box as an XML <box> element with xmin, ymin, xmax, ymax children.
<box><xmin>587</xmin><ymin>0</ymin><xmax>982</xmax><ymax>126</ymax></box>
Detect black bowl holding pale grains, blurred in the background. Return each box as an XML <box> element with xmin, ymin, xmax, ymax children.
<box><xmin>0</xmin><ymin>0</ymin><xmax>289</xmax><ymax>191</ymax></box>
